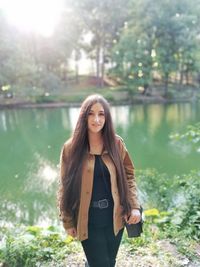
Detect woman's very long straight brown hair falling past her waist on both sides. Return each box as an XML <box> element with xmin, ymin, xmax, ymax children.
<box><xmin>59</xmin><ymin>95</ymin><xmax>130</xmax><ymax>223</ymax></box>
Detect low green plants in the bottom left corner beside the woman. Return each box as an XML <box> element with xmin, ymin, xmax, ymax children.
<box><xmin>0</xmin><ymin>226</ymin><xmax>80</xmax><ymax>267</ymax></box>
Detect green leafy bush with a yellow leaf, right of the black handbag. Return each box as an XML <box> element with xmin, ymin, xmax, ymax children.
<box><xmin>137</xmin><ymin>170</ymin><xmax>200</xmax><ymax>240</ymax></box>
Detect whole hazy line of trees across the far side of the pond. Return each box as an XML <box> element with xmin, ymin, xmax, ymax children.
<box><xmin>0</xmin><ymin>0</ymin><xmax>200</xmax><ymax>96</ymax></box>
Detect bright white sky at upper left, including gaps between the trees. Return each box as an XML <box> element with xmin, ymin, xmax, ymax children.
<box><xmin>0</xmin><ymin>0</ymin><xmax>94</xmax><ymax>74</ymax></box>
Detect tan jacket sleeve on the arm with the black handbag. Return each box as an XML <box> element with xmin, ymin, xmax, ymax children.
<box><xmin>118</xmin><ymin>137</ymin><xmax>140</xmax><ymax>209</ymax></box>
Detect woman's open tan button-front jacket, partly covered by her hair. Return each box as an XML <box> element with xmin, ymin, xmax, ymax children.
<box><xmin>60</xmin><ymin>136</ymin><xmax>140</xmax><ymax>241</ymax></box>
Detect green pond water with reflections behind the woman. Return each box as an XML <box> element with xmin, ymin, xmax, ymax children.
<box><xmin>0</xmin><ymin>103</ymin><xmax>200</xmax><ymax>225</ymax></box>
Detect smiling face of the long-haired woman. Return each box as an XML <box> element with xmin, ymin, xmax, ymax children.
<box><xmin>88</xmin><ymin>103</ymin><xmax>105</xmax><ymax>133</ymax></box>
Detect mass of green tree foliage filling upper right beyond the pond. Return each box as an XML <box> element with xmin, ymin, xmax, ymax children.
<box><xmin>113</xmin><ymin>0</ymin><xmax>199</xmax><ymax>97</ymax></box>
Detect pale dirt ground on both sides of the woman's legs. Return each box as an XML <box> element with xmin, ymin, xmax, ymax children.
<box><xmin>55</xmin><ymin>240</ymin><xmax>200</xmax><ymax>267</ymax></box>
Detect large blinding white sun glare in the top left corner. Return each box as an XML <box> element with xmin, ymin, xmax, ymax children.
<box><xmin>0</xmin><ymin>0</ymin><xmax>64</xmax><ymax>36</ymax></box>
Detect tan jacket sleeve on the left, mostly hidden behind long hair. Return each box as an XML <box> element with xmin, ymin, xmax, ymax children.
<box><xmin>59</xmin><ymin>142</ymin><xmax>74</xmax><ymax>230</ymax></box>
